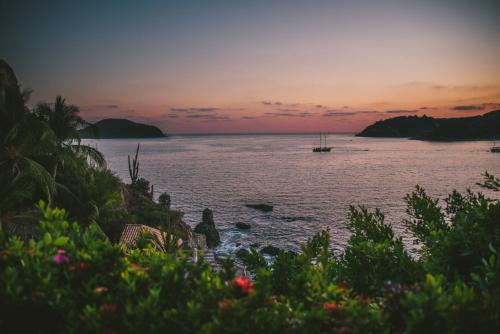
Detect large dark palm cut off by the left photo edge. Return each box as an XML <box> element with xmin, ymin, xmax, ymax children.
<box><xmin>0</xmin><ymin>60</ymin><xmax>55</xmax><ymax>218</ymax></box>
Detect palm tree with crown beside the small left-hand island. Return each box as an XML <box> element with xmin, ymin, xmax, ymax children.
<box><xmin>34</xmin><ymin>95</ymin><xmax>106</xmax><ymax>179</ymax></box>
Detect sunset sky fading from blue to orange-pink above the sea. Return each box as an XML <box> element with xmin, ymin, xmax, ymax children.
<box><xmin>0</xmin><ymin>0</ymin><xmax>500</xmax><ymax>133</ymax></box>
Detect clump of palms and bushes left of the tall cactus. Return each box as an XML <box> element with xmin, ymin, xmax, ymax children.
<box><xmin>0</xmin><ymin>64</ymin><xmax>121</xmax><ymax>228</ymax></box>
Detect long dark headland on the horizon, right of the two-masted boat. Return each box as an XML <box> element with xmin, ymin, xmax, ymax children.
<box><xmin>356</xmin><ymin>110</ymin><xmax>500</xmax><ymax>141</ymax></box>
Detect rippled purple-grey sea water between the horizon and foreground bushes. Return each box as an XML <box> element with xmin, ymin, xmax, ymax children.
<box><xmin>86</xmin><ymin>135</ymin><xmax>500</xmax><ymax>254</ymax></box>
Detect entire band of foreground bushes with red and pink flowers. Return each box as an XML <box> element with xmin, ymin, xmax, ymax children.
<box><xmin>0</xmin><ymin>177</ymin><xmax>500</xmax><ymax>333</ymax></box>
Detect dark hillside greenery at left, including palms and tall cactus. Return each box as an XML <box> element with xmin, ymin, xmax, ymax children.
<box><xmin>0</xmin><ymin>60</ymin><xmax>186</xmax><ymax>241</ymax></box>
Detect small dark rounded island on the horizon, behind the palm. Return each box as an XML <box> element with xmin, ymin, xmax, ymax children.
<box><xmin>80</xmin><ymin>118</ymin><xmax>165</xmax><ymax>139</ymax></box>
